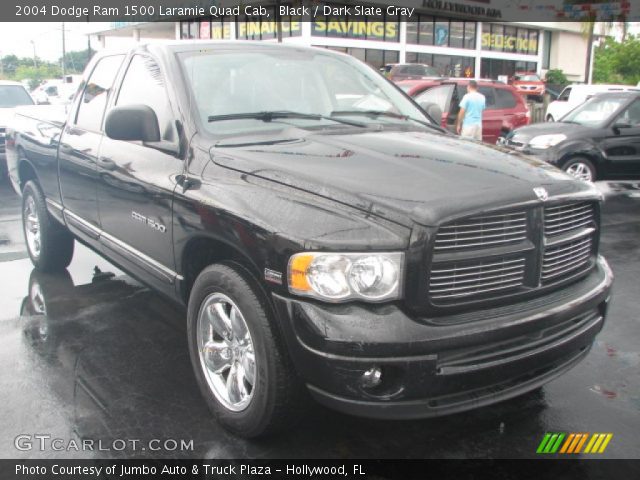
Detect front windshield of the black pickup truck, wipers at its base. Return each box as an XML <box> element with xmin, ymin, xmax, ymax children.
<box><xmin>180</xmin><ymin>47</ymin><xmax>429</xmax><ymax>135</ymax></box>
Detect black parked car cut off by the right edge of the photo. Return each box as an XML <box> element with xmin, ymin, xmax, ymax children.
<box><xmin>505</xmin><ymin>92</ymin><xmax>640</xmax><ymax>181</ymax></box>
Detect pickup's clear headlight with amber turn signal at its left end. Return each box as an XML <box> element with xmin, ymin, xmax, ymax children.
<box><xmin>288</xmin><ymin>252</ymin><xmax>404</xmax><ymax>302</ymax></box>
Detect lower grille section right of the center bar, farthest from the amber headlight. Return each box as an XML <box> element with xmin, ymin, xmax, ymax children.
<box><xmin>540</xmin><ymin>235</ymin><xmax>593</xmax><ymax>283</ymax></box>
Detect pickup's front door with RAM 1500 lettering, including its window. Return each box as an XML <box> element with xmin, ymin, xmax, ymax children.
<box><xmin>98</xmin><ymin>54</ymin><xmax>183</xmax><ymax>292</ymax></box>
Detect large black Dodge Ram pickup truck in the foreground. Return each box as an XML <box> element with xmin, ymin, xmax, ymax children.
<box><xmin>7</xmin><ymin>42</ymin><xmax>613</xmax><ymax>436</ymax></box>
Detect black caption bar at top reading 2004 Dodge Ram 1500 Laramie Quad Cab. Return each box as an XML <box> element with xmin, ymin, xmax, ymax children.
<box><xmin>0</xmin><ymin>0</ymin><xmax>640</xmax><ymax>22</ymax></box>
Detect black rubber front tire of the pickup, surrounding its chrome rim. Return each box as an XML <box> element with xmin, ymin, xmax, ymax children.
<box><xmin>187</xmin><ymin>263</ymin><xmax>308</xmax><ymax>438</ymax></box>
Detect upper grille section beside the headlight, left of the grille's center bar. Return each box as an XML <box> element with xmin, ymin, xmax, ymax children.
<box><xmin>435</xmin><ymin>212</ymin><xmax>527</xmax><ymax>253</ymax></box>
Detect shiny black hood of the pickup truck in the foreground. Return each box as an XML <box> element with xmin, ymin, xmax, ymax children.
<box><xmin>210</xmin><ymin>128</ymin><xmax>597</xmax><ymax>226</ymax></box>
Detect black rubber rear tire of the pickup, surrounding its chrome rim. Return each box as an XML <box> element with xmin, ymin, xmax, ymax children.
<box><xmin>22</xmin><ymin>181</ymin><xmax>74</xmax><ymax>272</ymax></box>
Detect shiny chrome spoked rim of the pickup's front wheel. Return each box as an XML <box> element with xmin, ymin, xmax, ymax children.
<box><xmin>197</xmin><ymin>293</ymin><xmax>257</xmax><ymax>412</ymax></box>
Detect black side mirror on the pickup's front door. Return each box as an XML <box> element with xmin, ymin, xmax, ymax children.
<box><xmin>104</xmin><ymin>105</ymin><xmax>160</xmax><ymax>142</ymax></box>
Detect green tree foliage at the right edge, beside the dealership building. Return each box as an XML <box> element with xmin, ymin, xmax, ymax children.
<box><xmin>593</xmin><ymin>35</ymin><xmax>640</xmax><ymax>85</ymax></box>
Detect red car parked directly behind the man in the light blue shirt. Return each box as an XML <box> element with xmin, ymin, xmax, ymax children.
<box><xmin>396</xmin><ymin>78</ymin><xmax>531</xmax><ymax>143</ymax></box>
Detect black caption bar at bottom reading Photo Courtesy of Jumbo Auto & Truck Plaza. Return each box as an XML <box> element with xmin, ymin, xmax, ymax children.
<box><xmin>0</xmin><ymin>459</ymin><xmax>640</xmax><ymax>480</ymax></box>
